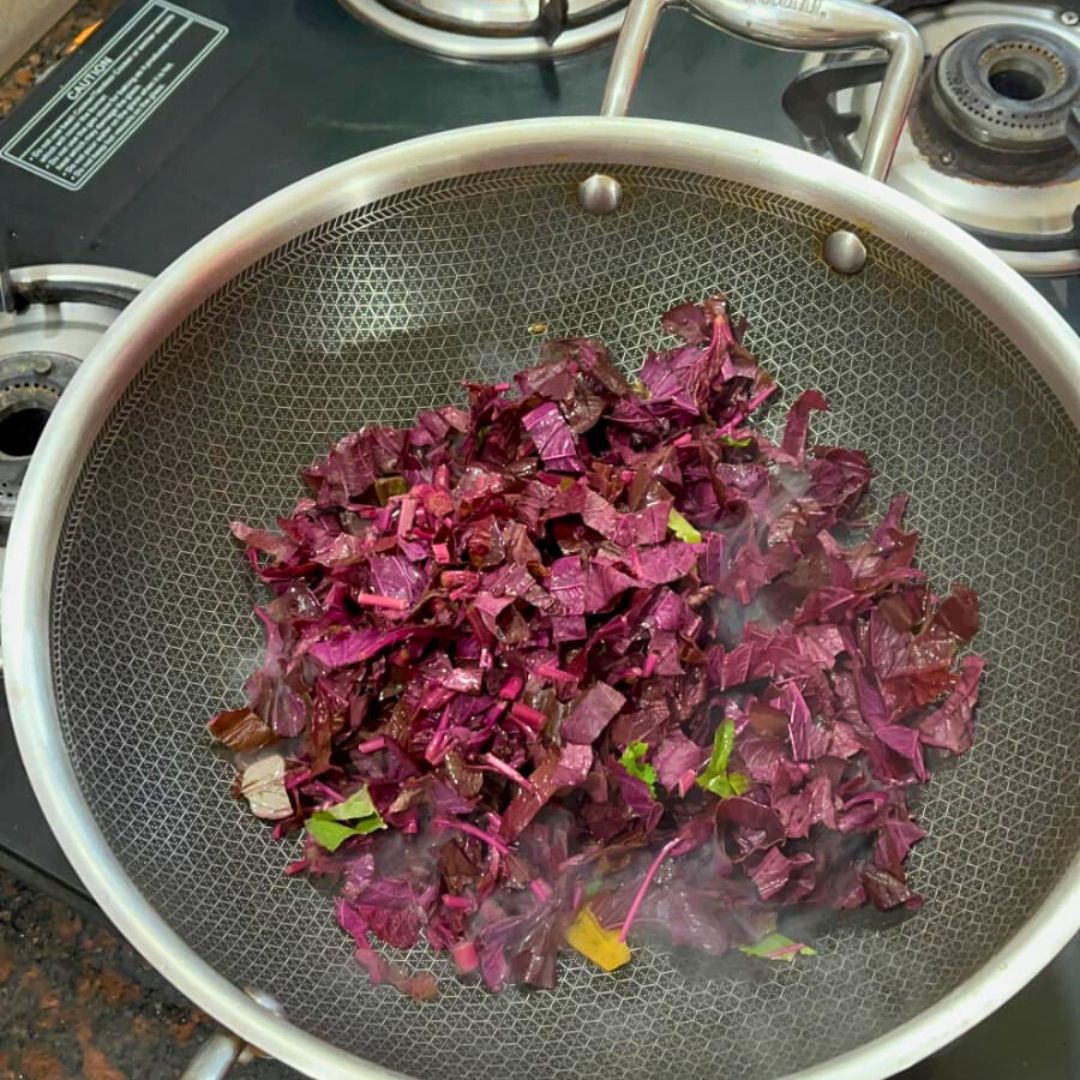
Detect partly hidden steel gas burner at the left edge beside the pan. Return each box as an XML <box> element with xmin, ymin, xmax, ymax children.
<box><xmin>0</xmin><ymin>266</ymin><xmax>150</xmax><ymax>537</ymax></box>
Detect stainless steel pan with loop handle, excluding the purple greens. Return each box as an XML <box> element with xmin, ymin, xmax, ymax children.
<box><xmin>3</xmin><ymin>0</ymin><xmax>1080</xmax><ymax>1080</ymax></box>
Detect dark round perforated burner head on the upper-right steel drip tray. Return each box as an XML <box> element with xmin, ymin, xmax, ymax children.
<box><xmin>932</xmin><ymin>26</ymin><xmax>1080</xmax><ymax>153</ymax></box>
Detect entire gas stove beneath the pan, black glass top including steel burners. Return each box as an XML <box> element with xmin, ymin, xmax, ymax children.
<box><xmin>0</xmin><ymin>0</ymin><xmax>1080</xmax><ymax>1080</ymax></box>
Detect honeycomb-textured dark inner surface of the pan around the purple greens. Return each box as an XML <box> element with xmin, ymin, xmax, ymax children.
<box><xmin>52</xmin><ymin>165</ymin><xmax>1080</xmax><ymax>1080</ymax></box>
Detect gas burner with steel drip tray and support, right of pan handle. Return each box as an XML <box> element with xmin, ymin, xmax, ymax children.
<box><xmin>785</xmin><ymin>0</ymin><xmax>1080</xmax><ymax>274</ymax></box>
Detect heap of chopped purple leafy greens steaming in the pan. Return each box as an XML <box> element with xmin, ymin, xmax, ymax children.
<box><xmin>210</xmin><ymin>297</ymin><xmax>983</xmax><ymax>999</ymax></box>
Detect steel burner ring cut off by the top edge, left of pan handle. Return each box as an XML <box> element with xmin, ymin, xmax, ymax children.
<box><xmin>340</xmin><ymin>0</ymin><xmax>629</xmax><ymax>60</ymax></box>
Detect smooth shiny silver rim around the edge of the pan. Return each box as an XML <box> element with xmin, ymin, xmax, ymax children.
<box><xmin>0</xmin><ymin>117</ymin><xmax>1080</xmax><ymax>1080</ymax></box>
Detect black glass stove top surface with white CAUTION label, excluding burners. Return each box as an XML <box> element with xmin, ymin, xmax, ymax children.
<box><xmin>0</xmin><ymin>0</ymin><xmax>1080</xmax><ymax>1080</ymax></box>
